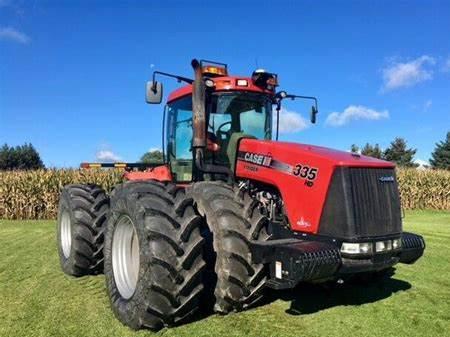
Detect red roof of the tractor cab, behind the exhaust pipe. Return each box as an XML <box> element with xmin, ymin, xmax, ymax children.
<box><xmin>167</xmin><ymin>76</ymin><xmax>275</xmax><ymax>103</ymax></box>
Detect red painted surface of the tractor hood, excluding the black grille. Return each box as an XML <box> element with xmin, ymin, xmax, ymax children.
<box><xmin>236</xmin><ymin>139</ymin><xmax>394</xmax><ymax>234</ymax></box>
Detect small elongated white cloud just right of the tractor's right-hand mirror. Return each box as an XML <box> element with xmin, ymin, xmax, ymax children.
<box><xmin>325</xmin><ymin>105</ymin><xmax>389</xmax><ymax>126</ymax></box>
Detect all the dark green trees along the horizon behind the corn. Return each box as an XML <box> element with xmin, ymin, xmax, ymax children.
<box><xmin>0</xmin><ymin>131</ymin><xmax>450</xmax><ymax>170</ymax></box>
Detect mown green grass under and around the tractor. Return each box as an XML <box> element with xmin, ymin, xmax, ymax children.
<box><xmin>0</xmin><ymin>211</ymin><xmax>450</xmax><ymax>337</ymax></box>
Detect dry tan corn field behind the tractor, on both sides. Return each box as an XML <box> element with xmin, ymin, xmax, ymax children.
<box><xmin>0</xmin><ymin>169</ymin><xmax>450</xmax><ymax>219</ymax></box>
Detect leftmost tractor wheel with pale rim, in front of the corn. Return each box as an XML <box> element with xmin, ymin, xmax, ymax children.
<box><xmin>57</xmin><ymin>184</ymin><xmax>109</xmax><ymax>276</ymax></box>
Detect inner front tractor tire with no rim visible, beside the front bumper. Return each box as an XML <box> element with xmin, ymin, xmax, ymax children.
<box><xmin>192</xmin><ymin>182</ymin><xmax>269</xmax><ymax>313</ymax></box>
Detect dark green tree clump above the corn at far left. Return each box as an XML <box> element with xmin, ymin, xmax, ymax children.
<box><xmin>0</xmin><ymin>144</ymin><xmax>45</xmax><ymax>170</ymax></box>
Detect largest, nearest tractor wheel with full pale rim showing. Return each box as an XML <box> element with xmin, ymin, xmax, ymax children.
<box><xmin>105</xmin><ymin>181</ymin><xmax>206</xmax><ymax>330</ymax></box>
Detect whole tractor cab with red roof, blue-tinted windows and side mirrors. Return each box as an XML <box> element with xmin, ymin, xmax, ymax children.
<box><xmin>147</xmin><ymin>60</ymin><xmax>317</xmax><ymax>183</ymax></box>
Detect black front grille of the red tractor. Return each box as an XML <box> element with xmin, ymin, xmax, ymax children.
<box><xmin>319</xmin><ymin>168</ymin><xmax>401</xmax><ymax>239</ymax></box>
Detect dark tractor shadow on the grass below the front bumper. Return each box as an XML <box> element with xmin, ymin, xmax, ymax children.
<box><xmin>268</xmin><ymin>272</ymin><xmax>411</xmax><ymax>315</ymax></box>
